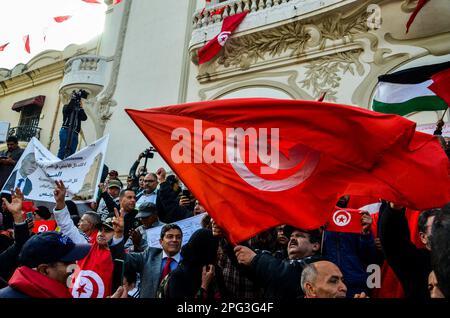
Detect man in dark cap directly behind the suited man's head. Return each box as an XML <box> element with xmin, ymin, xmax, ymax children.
<box><xmin>125</xmin><ymin>202</ymin><xmax>165</xmax><ymax>252</ymax></box>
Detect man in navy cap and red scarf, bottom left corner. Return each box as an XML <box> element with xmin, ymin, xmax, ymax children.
<box><xmin>0</xmin><ymin>232</ymin><xmax>90</xmax><ymax>298</ymax></box>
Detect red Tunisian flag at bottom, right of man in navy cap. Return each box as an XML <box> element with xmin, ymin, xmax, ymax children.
<box><xmin>71</xmin><ymin>241</ymin><xmax>114</xmax><ymax>298</ymax></box>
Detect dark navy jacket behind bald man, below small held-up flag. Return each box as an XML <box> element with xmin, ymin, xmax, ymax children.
<box><xmin>322</xmin><ymin>231</ymin><xmax>377</xmax><ymax>298</ymax></box>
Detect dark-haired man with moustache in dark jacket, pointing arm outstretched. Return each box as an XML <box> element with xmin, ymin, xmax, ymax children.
<box><xmin>234</xmin><ymin>226</ymin><xmax>322</xmax><ymax>299</ymax></box>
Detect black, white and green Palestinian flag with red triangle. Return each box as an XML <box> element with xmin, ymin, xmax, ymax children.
<box><xmin>372</xmin><ymin>62</ymin><xmax>450</xmax><ymax>116</ymax></box>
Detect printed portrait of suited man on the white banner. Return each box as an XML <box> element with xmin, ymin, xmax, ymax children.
<box><xmin>4</xmin><ymin>152</ymin><xmax>38</xmax><ymax>196</ymax></box>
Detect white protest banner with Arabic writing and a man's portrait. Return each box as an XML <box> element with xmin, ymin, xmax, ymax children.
<box><xmin>1</xmin><ymin>136</ymin><xmax>109</xmax><ymax>202</ymax></box>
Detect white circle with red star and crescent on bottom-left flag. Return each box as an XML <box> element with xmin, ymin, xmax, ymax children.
<box><xmin>72</xmin><ymin>270</ymin><xmax>105</xmax><ymax>298</ymax></box>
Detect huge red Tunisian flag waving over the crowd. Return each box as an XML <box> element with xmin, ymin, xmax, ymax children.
<box><xmin>126</xmin><ymin>99</ymin><xmax>450</xmax><ymax>242</ymax></box>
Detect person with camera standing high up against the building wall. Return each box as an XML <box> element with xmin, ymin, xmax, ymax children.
<box><xmin>58</xmin><ymin>90</ymin><xmax>88</xmax><ymax>160</ymax></box>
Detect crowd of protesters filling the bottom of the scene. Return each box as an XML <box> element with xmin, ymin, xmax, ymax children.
<box><xmin>0</xmin><ymin>143</ymin><xmax>450</xmax><ymax>299</ymax></box>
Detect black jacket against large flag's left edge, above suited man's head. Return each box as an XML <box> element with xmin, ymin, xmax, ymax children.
<box><xmin>156</xmin><ymin>182</ymin><xmax>194</xmax><ymax>223</ymax></box>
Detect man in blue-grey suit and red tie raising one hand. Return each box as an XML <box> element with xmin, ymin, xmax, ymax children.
<box><xmin>110</xmin><ymin>211</ymin><xmax>183</xmax><ymax>298</ymax></box>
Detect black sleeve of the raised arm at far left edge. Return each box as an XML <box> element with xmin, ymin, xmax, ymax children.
<box><xmin>0</xmin><ymin>222</ymin><xmax>30</xmax><ymax>281</ymax></box>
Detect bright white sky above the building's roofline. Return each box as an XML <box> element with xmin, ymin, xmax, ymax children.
<box><xmin>0</xmin><ymin>0</ymin><xmax>107</xmax><ymax>69</ymax></box>
